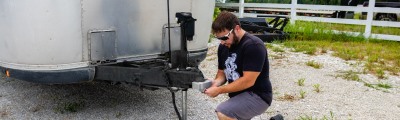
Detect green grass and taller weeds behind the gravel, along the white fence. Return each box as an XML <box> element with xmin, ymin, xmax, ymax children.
<box><xmin>283</xmin><ymin>24</ymin><xmax>400</xmax><ymax>78</ymax></box>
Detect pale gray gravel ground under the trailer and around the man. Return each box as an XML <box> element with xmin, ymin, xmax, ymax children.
<box><xmin>0</xmin><ymin>41</ymin><xmax>400</xmax><ymax>120</ymax></box>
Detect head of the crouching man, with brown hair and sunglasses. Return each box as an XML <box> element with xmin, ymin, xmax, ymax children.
<box><xmin>212</xmin><ymin>12</ymin><xmax>242</xmax><ymax>48</ymax></box>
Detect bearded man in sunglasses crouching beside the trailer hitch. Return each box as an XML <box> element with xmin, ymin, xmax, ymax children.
<box><xmin>204</xmin><ymin>12</ymin><xmax>272</xmax><ymax>120</ymax></box>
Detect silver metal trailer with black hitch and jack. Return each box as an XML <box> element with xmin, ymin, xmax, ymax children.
<box><xmin>0</xmin><ymin>0</ymin><xmax>215</xmax><ymax>119</ymax></box>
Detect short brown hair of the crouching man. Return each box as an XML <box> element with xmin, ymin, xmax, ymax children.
<box><xmin>212</xmin><ymin>11</ymin><xmax>240</xmax><ymax>34</ymax></box>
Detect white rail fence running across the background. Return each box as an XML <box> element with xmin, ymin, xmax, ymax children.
<box><xmin>216</xmin><ymin>0</ymin><xmax>400</xmax><ymax>41</ymax></box>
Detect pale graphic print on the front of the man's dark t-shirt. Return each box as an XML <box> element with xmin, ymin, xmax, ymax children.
<box><xmin>224</xmin><ymin>53</ymin><xmax>239</xmax><ymax>81</ymax></box>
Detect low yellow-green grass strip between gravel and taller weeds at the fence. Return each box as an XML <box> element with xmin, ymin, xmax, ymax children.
<box><xmin>283</xmin><ymin>35</ymin><xmax>400</xmax><ymax>78</ymax></box>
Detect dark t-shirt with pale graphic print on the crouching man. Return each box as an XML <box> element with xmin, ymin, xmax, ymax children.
<box><xmin>218</xmin><ymin>33</ymin><xmax>272</xmax><ymax>105</ymax></box>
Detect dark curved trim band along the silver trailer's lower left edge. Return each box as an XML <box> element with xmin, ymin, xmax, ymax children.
<box><xmin>0</xmin><ymin>66</ymin><xmax>95</xmax><ymax>84</ymax></box>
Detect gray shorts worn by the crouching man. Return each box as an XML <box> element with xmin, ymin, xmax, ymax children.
<box><xmin>216</xmin><ymin>92</ymin><xmax>269</xmax><ymax>120</ymax></box>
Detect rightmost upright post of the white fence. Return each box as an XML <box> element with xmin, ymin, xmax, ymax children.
<box><xmin>364</xmin><ymin>0</ymin><xmax>375</xmax><ymax>38</ymax></box>
